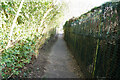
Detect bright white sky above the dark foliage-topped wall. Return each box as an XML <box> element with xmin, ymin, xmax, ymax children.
<box><xmin>64</xmin><ymin>0</ymin><xmax>110</xmax><ymax>17</ymax></box>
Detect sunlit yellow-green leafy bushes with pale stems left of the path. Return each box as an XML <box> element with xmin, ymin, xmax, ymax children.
<box><xmin>0</xmin><ymin>0</ymin><xmax>63</xmax><ymax>78</ymax></box>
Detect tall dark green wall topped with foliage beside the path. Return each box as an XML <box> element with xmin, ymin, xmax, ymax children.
<box><xmin>64</xmin><ymin>2</ymin><xmax>120</xmax><ymax>77</ymax></box>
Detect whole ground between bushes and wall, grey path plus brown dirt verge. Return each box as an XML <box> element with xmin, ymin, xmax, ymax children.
<box><xmin>18</xmin><ymin>35</ymin><xmax>83</xmax><ymax>78</ymax></box>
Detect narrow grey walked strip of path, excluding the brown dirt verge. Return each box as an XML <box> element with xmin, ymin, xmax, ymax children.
<box><xmin>43</xmin><ymin>35</ymin><xmax>78</xmax><ymax>78</ymax></box>
